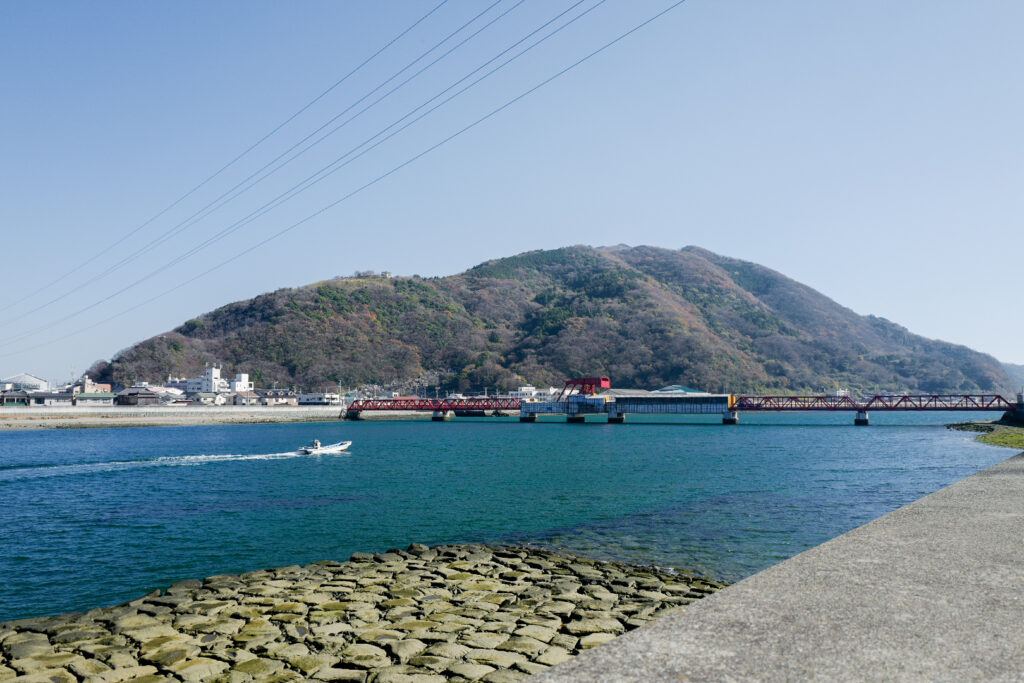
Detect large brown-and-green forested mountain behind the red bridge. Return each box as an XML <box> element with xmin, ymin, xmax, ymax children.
<box><xmin>92</xmin><ymin>246</ymin><xmax>1013</xmax><ymax>392</ymax></box>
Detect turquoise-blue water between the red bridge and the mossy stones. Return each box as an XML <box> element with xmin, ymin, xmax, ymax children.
<box><xmin>0</xmin><ymin>414</ymin><xmax>1013</xmax><ymax>621</ymax></box>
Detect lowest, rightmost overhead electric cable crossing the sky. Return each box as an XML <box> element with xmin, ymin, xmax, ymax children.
<box><xmin>0</xmin><ymin>0</ymin><xmax>686</xmax><ymax>357</ymax></box>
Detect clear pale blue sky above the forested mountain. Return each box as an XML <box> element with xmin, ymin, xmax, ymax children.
<box><xmin>0</xmin><ymin>0</ymin><xmax>1024</xmax><ymax>380</ymax></box>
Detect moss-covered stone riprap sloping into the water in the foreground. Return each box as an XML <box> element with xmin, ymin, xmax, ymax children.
<box><xmin>0</xmin><ymin>545</ymin><xmax>722</xmax><ymax>683</ymax></box>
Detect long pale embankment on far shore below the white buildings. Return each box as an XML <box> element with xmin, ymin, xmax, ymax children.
<box><xmin>0</xmin><ymin>405</ymin><xmax>342</xmax><ymax>430</ymax></box>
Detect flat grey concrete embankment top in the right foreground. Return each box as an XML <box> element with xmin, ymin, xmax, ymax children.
<box><xmin>539</xmin><ymin>454</ymin><xmax>1024</xmax><ymax>682</ymax></box>
